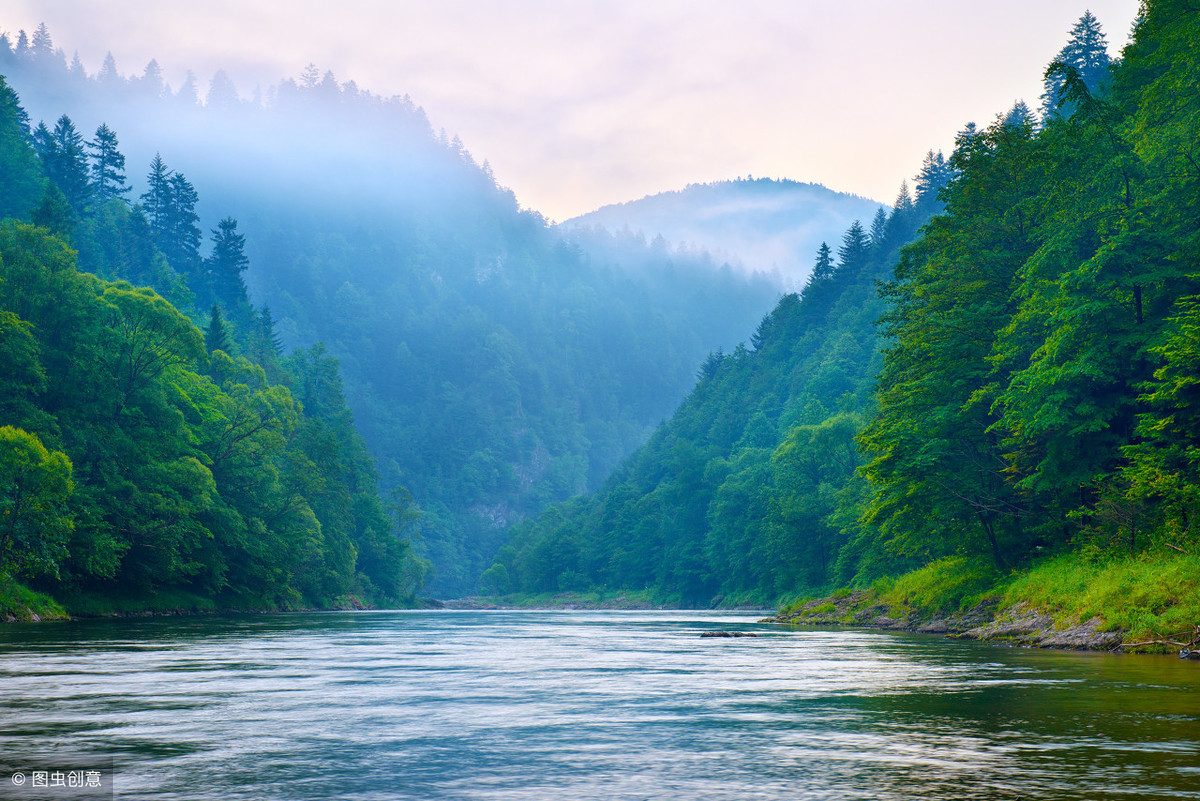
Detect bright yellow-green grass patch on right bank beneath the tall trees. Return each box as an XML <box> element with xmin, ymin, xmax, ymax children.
<box><xmin>1003</xmin><ymin>554</ymin><xmax>1200</xmax><ymax>642</ymax></box>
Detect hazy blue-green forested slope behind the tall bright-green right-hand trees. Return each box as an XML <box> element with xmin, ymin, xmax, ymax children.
<box><xmin>482</xmin><ymin>153</ymin><xmax>950</xmax><ymax>604</ymax></box>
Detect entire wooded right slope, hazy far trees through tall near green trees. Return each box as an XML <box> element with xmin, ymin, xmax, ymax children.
<box><xmin>485</xmin><ymin>0</ymin><xmax>1200</xmax><ymax>603</ymax></box>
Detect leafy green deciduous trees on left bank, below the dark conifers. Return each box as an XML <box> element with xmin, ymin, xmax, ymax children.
<box><xmin>0</xmin><ymin>211</ymin><xmax>426</xmax><ymax>608</ymax></box>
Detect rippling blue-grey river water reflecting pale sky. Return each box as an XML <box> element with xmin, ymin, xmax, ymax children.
<box><xmin>0</xmin><ymin>610</ymin><xmax>1200</xmax><ymax>801</ymax></box>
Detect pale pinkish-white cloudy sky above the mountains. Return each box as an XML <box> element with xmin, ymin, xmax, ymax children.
<box><xmin>0</xmin><ymin>0</ymin><xmax>1138</xmax><ymax>221</ymax></box>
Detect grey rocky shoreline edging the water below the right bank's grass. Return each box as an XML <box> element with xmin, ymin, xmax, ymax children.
<box><xmin>762</xmin><ymin>591</ymin><xmax>1129</xmax><ymax>651</ymax></box>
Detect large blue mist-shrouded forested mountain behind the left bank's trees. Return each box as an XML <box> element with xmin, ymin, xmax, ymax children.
<box><xmin>0</xmin><ymin>28</ymin><xmax>779</xmax><ymax>595</ymax></box>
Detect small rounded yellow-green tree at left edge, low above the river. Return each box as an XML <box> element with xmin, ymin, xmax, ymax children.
<box><xmin>0</xmin><ymin>426</ymin><xmax>74</xmax><ymax>577</ymax></box>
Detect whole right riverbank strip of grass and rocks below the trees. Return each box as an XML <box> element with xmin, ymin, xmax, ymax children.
<box><xmin>767</xmin><ymin>554</ymin><xmax>1200</xmax><ymax>652</ymax></box>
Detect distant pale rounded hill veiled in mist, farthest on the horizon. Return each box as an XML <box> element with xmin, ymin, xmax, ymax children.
<box><xmin>560</xmin><ymin>179</ymin><xmax>881</xmax><ymax>288</ymax></box>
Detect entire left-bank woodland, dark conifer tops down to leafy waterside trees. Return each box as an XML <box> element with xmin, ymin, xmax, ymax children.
<box><xmin>0</xmin><ymin>77</ymin><xmax>428</xmax><ymax>608</ymax></box>
